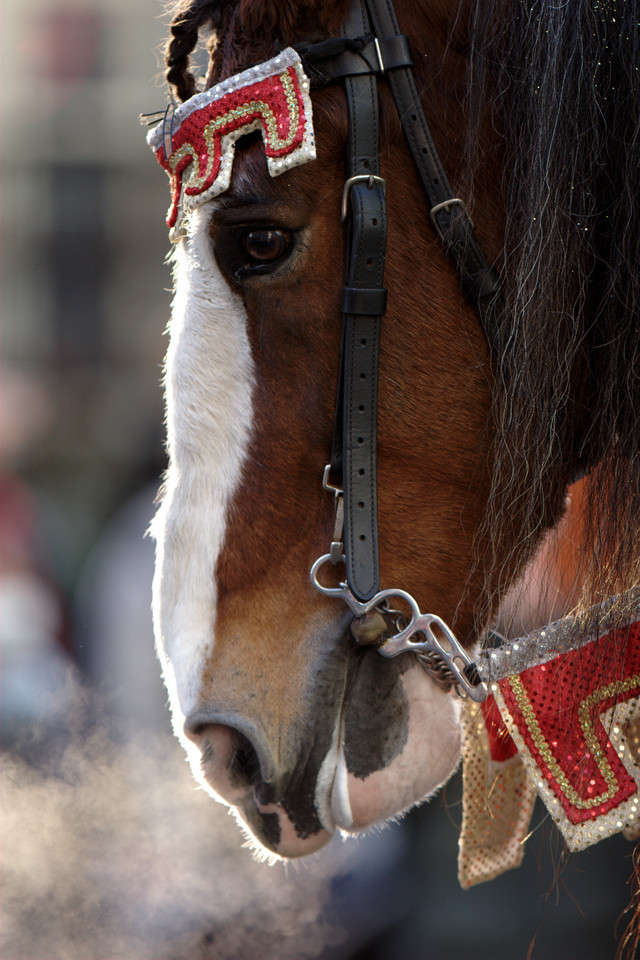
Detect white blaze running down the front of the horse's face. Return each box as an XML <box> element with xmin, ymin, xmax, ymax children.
<box><xmin>152</xmin><ymin>204</ymin><xmax>254</xmax><ymax>734</ymax></box>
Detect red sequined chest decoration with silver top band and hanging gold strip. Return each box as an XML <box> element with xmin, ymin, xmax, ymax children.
<box><xmin>458</xmin><ymin>588</ymin><xmax>640</xmax><ymax>887</ymax></box>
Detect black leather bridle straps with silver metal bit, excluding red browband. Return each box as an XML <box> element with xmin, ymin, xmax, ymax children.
<box><xmin>302</xmin><ymin>0</ymin><xmax>502</xmax><ymax>700</ymax></box>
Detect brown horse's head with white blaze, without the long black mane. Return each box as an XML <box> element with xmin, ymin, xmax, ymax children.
<box><xmin>154</xmin><ymin>0</ymin><xmax>640</xmax><ymax>856</ymax></box>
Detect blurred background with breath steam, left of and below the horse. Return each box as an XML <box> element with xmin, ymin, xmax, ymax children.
<box><xmin>0</xmin><ymin>0</ymin><xmax>631</xmax><ymax>960</ymax></box>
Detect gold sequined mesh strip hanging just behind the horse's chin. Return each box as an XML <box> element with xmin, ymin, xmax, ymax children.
<box><xmin>458</xmin><ymin>700</ymin><xmax>536</xmax><ymax>887</ymax></box>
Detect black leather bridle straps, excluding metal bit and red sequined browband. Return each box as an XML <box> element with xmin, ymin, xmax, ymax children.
<box><xmin>318</xmin><ymin>0</ymin><xmax>502</xmax><ymax>601</ymax></box>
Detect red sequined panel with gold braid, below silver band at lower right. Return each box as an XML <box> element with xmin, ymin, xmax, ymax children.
<box><xmin>490</xmin><ymin>623</ymin><xmax>640</xmax><ymax>850</ymax></box>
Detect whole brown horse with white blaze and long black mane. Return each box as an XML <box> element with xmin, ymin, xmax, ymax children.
<box><xmin>145</xmin><ymin>0</ymin><xmax>640</xmax><ymax>888</ymax></box>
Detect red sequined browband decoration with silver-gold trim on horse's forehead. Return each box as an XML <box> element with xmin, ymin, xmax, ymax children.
<box><xmin>147</xmin><ymin>47</ymin><xmax>316</xmax><ymax>239</ymax></box>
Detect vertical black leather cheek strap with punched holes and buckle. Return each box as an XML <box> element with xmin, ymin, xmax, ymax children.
<box><xmin>332</xmin><ymin>3</ymin><xmax>387</xmax><ymax>601</ymax></box>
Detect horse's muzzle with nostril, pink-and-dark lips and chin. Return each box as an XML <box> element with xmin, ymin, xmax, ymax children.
<box><xmin>184</xmin><ymin>651</ymin><xmax>459</xmax><ymax>858</ymax></box>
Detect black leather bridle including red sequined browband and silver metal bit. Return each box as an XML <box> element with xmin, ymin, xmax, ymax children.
<box><xmin>146</xmin><ymin>0</ymin><xmax>503</xmax><ymax>700</ymax></box>
